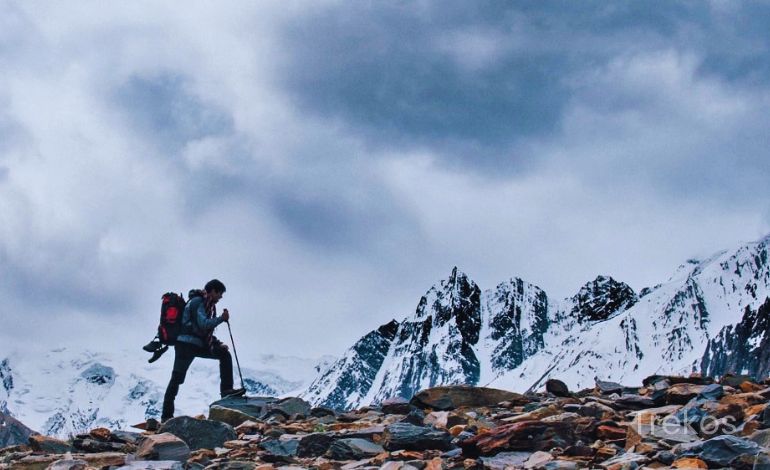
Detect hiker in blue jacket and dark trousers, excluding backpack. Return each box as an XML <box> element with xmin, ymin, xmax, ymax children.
<box><xmin>161</xmin><ymin>279</ymin><xmax>245</xmax><ymax>422</ymax></box>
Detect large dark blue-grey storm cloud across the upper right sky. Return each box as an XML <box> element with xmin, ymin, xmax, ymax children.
<box><xmin>284</xmin><ymin>1</ymin><xmax>770</xmax><ymax>176</ymax></box>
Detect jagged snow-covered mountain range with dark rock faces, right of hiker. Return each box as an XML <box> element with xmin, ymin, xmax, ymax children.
<box><xmin>303</xmin><ymin>233</ymin><xmax>770</xmax><ymax>408</ymax></box>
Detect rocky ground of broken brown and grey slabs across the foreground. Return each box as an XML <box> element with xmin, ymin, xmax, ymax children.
<box><xmin>0</xmin><ymin>376</ymin><xmax>770</xmax><ymax>470</ymax></box>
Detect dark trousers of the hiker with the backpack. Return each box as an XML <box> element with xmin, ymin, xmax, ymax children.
<box><xmin>161</xmin><ymin>343</ymin><xmax>233</xmax><ymax>421</ymax></box>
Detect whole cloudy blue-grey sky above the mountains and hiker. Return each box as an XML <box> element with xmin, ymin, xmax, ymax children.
<box><xmin>0</xmin><ymin>0</ymin><xmax>770</xmax><ymax>363</ymax></box>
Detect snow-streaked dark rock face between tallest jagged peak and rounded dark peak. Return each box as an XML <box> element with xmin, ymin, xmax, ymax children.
<box><xmin>489</xmin><ymin>278</ymin><xmax>548</xmax><ymax>372</ymax></box>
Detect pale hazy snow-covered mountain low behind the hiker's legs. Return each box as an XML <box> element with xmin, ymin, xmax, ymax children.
<box><xmin>0</xmin><ymin>348</ymin><xmax>333</xmax><ymax>437</ymax></box>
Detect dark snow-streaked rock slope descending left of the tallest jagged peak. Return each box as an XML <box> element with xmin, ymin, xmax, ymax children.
<box><xmin>304</xmin><ymin>320</ymin><xmax>399</xmax><ymax>409</ymax></box>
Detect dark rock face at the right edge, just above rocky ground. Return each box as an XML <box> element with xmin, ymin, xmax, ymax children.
<box><xmin>701</xmin><ymin>299</ymin><xmax>770</xmax><ymax>377</ymax></box>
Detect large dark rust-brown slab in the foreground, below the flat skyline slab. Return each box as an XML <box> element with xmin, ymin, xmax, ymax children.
<box><xmin>460</xmin><ymin>421</ymin><xmax>575</xmax><ymax>457</ymax></box>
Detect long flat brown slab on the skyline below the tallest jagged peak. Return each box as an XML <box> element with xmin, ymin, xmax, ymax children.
<box><xmin>411</xmin><ymin>385</ymin><xmax>529</xmax><ymax>411</ymax></box>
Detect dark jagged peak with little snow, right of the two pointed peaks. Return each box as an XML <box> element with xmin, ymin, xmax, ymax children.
<box><xmin>572</xmin><ymin>276</ymin><xmax>639</xmax><ymax>323</ymax></box>
